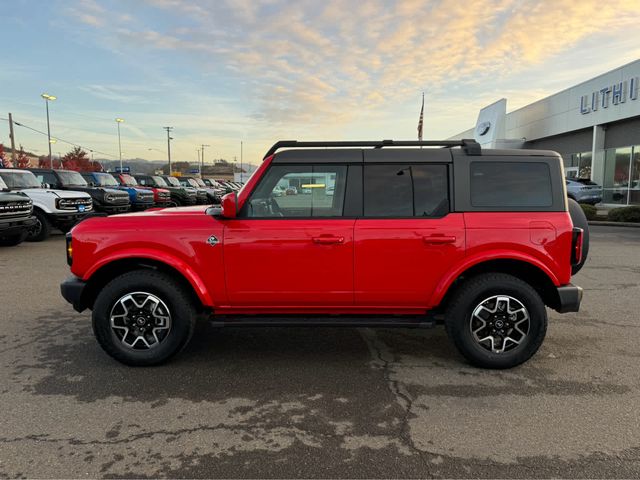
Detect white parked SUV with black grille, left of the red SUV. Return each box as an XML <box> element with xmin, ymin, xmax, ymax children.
<box><xmin>0</xmin><ymin>168</ymin><xmax>93</xmax><ymax>242</ymax></box>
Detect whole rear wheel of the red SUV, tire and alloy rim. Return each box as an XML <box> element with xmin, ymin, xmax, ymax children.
<box><xmin>445</xmin><ymin>273</ymin><xmax>547</xmax><ymax>369</ymax></box>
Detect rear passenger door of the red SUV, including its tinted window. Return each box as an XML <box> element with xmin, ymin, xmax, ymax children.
<box><xmin>354</xmin><ymin>149</ymin><xmax>465</xmax><ymax>308</ymax></box>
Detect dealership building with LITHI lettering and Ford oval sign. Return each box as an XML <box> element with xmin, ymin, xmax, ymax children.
<box><xmin>451</xmin><ymin>60</ymin><xmax>640</xmax><ymax>206</ymax></box>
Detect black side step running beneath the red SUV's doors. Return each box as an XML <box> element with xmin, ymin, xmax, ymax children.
<box><xmin>209</xmin><ymin>315</ymin><xmax>436</xmax><ymax>328</ymax></box>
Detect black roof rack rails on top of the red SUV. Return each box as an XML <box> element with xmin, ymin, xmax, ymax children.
<box><xmin>264</xmin><ymin>138</ymin><xmax>482</xmax><ymax>158</ymax></box>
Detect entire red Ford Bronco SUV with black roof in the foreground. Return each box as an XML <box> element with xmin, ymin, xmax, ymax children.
<box><xmin>61</xmin><ymin>140</ymin><xmax>588</xmax><ymax>368</ymax></box>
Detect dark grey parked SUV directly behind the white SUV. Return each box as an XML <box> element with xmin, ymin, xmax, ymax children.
<box><xmin>30</xmin><ymin>168</ymin><xmax>131</xmax><ymax>214</ymax></box>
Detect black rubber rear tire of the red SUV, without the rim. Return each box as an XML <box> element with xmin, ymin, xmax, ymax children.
<box><xmin>445</xmin><ymin>273</ymin><xmax>547</xmax><ymax>369</ymax></box>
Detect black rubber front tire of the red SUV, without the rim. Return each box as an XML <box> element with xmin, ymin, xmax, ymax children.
<box><xmin>92</xmin><ymin>270</ymin><xmax>196</xmax><ymax>366</ymax></box>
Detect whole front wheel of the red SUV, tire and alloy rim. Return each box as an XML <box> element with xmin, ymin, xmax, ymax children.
<box><xmin>92</xmin><ymin>270</ymin><xmax>196</xmax><ymax>366</ymax></box>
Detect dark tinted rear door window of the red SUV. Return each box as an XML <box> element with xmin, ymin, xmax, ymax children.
<box><xmin>364</xmin><ymin>164</ymin><xmax>449</xmax><ymax>217</ymax></box>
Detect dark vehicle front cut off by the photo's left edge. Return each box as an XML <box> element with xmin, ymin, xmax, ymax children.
<box><xmin>0</xmin><ymin>176</ymin><xmax>36</xmax><ymax>247</ymax></box>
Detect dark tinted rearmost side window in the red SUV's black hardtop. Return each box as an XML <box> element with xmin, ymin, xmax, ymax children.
<box><xmin>470</xmin><ymin>162</ymin><xmax>553</xmax><ymax>208</ymax></box>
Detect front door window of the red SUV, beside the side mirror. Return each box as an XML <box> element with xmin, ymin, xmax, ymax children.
<box><xmin>244</xmin><ymin>165</ymin><xmax>348</xmax><ymax>218</ymax></box>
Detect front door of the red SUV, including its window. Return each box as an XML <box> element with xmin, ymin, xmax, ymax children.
<box><xmin>223</xmin><ymin>163</ymin><xmax>355</xmax><ymax>308</ymax></box>
